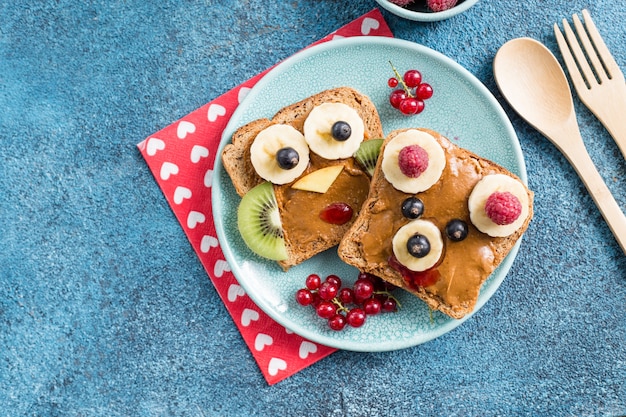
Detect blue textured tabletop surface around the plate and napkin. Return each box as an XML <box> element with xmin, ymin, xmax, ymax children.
<box><xmin>0</xmin><ymin>0</ymin><xmax>626</xmax><ymax>417</ymax></box>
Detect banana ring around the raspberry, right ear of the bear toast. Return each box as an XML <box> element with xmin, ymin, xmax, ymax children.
<box><xmin>467</xmin><ymin>174</ymin><xmax>529</xmax><ymax>237</ymax></box>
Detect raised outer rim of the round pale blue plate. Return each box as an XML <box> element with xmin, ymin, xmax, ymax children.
<box><xmin>211</xmin><ymin>36</ymin><xmax>528</xmax><ymax>352</ymax></box>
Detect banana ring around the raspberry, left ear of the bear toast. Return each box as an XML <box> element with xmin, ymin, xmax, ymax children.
<box><xmin>382</xmin><ymin>129</ymin><xmax>446</xmax><ymax>194</ymax></box>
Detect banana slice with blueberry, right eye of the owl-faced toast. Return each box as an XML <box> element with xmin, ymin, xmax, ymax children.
<box><xmin>304</xmin><ymin>103</ymin><xmax>365</xmax><ymax>160</ymax></box>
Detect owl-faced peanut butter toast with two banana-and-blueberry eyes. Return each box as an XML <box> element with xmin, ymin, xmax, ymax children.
<box><xmin>221</xmin><ymin>87</ymin><xmax>383</xmax><ymax>270</ymax></box>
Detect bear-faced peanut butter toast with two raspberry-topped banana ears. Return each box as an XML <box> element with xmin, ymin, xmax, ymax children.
<box><xmin>338</xmin><ymin>129</ymin><xmax>533</xmax><ymax>319</ymax></box>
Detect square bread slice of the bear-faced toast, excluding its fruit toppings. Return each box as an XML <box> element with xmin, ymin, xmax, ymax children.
<box><xmin>338</xmin><ymin>129</ymin><xmax>533</xmax><ymax>318</ymax></box>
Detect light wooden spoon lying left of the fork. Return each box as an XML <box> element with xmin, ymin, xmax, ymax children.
<box><xmin>493</xmin><ymin>38</ymin><xmax>626</xmax><ymax>253</ymax></box>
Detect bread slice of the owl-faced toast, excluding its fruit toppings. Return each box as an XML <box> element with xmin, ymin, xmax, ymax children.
<box><xmin>221</xmin><ymin>87</ymin><xmax>383</xmax><ymax>270</ymax></box>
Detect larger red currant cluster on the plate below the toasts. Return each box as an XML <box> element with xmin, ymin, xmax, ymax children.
<box><xmin>296</xmin><ymin>272</ymin><xmax>400</xmax><ymax>330</ymax></box>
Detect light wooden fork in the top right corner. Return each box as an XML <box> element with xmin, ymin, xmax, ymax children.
<box><xmin>554</xmin><ymin>10</ymin><xmax>626</xmax><ymax>158</ymax></box>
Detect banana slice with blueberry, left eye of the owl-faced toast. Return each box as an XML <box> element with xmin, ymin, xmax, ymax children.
<box><xmin>250</xmin><ymin>124</ymin><xmax>309</xmax><ymax>185</ymax></box>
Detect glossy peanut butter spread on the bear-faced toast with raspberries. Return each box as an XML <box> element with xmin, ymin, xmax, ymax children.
<box><xmin>361</xmin><ymin>131</ymin><xmax>500</xmax><ymax>306</ymax></box>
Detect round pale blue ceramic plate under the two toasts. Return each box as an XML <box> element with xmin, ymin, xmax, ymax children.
<box><xmin>212</xmin><ymin>37</ymin><xmax>526</xmax><ymax>352</ymax></box>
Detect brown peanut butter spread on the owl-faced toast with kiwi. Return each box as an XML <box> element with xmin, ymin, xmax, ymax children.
<box><xmin>274</xmin><ymin>154</ymin><xmax>370</xmax><ymax>250</ymax></box>
